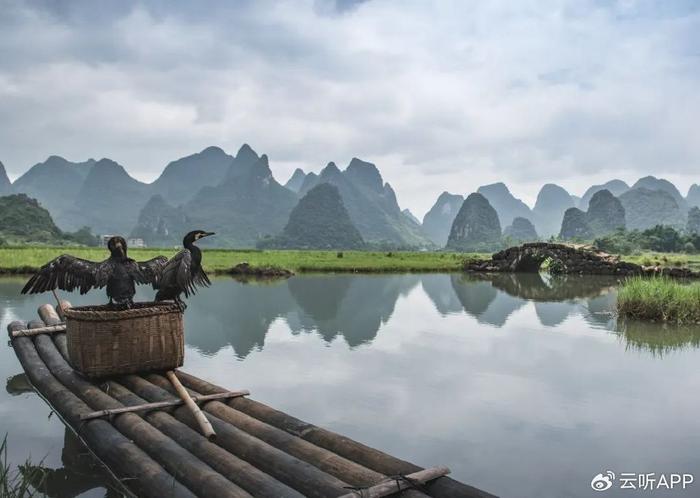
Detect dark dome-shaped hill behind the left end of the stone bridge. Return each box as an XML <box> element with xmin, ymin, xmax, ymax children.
<box><xmin>447</xmin><ymin>192</ymin><xmax>501</xmax><ymax>251</ymax></box>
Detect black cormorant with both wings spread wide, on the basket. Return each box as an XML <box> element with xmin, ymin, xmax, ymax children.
<box><xmin>22</xmin><ymin>237</ymin><xmax>168</xmax><ymax>308</ymax></box>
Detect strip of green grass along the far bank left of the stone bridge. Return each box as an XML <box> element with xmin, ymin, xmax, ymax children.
<box><xmin>0</xmin><ymin>246</ymin><xmax>490</xmax><ymax>273</ymax></box>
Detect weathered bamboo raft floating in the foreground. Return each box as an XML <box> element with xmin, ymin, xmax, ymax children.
<box><xmin>8</xmin><ymin>303</ymin><xmax>493</xmax><ymax>498</ymax></box>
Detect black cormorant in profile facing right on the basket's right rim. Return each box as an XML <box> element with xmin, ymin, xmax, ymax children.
<box><xmin>153</xmin><ymin>230</ymin><xmax>214</xmax><ymax>310</ymax></box>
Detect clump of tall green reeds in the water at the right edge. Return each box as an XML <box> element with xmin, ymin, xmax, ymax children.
<box><xmin>617</xmin><ymin>277</ymin><xmax>700</xmax><ymax>323</ymax></box>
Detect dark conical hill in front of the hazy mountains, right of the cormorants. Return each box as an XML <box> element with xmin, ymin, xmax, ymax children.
<box><xmin>258</xmin><ymin>183</ymin><xmax>365</xmax><ymax>249</ymax></box>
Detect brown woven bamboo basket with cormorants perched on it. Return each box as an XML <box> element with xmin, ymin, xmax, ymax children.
<box><xmin>65</xmin><ymin>303</ymin><xmax>185</xmax><ymax>378</ymax></box>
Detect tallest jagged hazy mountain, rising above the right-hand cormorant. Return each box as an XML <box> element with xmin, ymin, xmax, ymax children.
<box><xmin>184</xmin><ymin>149</ymin><xmax>297</xmax><ymax>247</ymax></box>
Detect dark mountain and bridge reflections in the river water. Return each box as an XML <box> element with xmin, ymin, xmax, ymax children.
<box><xmin>187</xmin><ymin>274</ymin><xmax>617</xmax><ymax>359</ymax></box>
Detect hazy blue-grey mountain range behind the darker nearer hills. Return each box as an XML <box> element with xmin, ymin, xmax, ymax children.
<box><xmin>0</xmin><ymin>144</ymin><xmax>700</xmax><ymax>247</ymax></box>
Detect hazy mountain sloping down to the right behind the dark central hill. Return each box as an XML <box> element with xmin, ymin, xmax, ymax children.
<box><xmin>299</xmin><ymin>158</ymin><xmax>429</xmax><ymax>246</ymax></box>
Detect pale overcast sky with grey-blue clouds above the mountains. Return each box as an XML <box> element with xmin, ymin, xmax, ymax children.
<box><xmin>0</xmin><ymin>0</ymin><xmax>700</xmax><ymax>216</ymax></box>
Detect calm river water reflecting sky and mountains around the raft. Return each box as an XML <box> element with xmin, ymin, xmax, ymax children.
<box><xmin>0</xmin><ymin>274</ymin><xmax>700</xmax><ymax>498</ymax></box>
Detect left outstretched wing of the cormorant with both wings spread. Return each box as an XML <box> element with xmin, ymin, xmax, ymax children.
<box><xmin>22</xmin><ymin>254</ymin><xmax>113</xmax><ymax>294</ymax></box>
